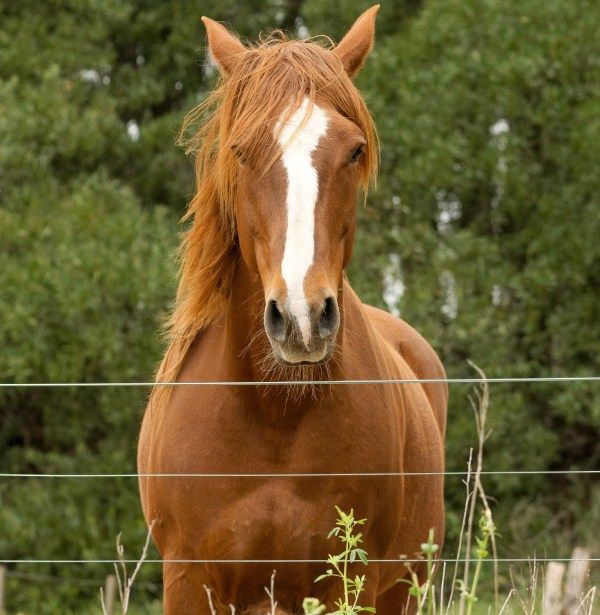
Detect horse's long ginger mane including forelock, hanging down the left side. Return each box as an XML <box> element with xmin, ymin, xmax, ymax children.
<box><xmin>151</xmin><ymin>32</ymin><xmax>379</xmax><ymax>410</ymax></box>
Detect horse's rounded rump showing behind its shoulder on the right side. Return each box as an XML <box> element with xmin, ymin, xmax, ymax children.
<box><xmin>363</xmin><ymin>304</ymin><xmax>448</xmax><ymax>438</ymax></box>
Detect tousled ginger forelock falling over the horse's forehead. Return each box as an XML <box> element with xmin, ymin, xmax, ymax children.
<box><xmin>180</xmin><ymin>33</ymin><xmax>378</xmax><ymax>209</ymax></box>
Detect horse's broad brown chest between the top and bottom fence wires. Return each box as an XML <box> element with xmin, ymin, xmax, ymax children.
<box><xmin>152</xmin><ymin>393</ymin><xmax>402</xmax><ymax>559</ymax></box>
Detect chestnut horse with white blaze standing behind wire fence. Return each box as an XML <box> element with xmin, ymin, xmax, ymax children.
<box><xmin>138</xmin><ymin>6</ymin><xmax>448</xmax><ymax>615</ymax></box>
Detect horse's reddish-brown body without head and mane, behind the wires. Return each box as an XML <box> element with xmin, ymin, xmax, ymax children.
<box><xmin>139</xmin><ymin>264</ymin><xmax>446</xmax><ymax>615</ymax></box>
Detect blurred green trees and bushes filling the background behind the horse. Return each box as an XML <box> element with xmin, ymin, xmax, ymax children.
<box><xmin>0</xmin><ymin>0</ymin><xmax>600</xmax><ymax>614</ymax></box>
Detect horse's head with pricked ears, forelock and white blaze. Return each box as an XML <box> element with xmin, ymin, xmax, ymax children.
<box><xmin>198</xmin><ymin>7</ymin><xmax>378</xmax><ymax>365</ymax></box>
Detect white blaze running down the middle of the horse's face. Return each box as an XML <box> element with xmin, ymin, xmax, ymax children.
<box><xmin>276</xmin><ymin>98</ymin><xmax>327</xmax><ymax>346</ymax></box>
